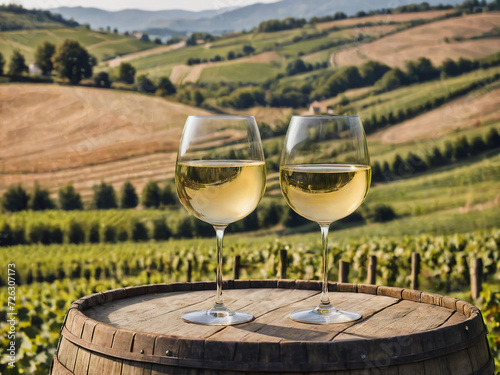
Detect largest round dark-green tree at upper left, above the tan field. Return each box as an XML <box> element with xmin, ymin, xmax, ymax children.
<box><xmin>53</xmin><ymin>39</ymin><xmax>97</xmax><ymax>85</ymax></box>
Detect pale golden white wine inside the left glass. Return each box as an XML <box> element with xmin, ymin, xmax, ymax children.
<box><xmin>175</xmin><ymin>160</ymin><xmax>266</xmax><ymax>225</ymax></box>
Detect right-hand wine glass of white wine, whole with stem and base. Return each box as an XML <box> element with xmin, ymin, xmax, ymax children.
<box><xmin>280</xmin><ymin>116</ymin><xmax>371</xmax><ymax>324</ymax></box>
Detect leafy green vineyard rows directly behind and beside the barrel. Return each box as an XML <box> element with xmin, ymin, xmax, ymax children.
<box><xmin>0</xmin><ymin>229</ymin><xmax>500</xmax><ymax>374</ymax></box>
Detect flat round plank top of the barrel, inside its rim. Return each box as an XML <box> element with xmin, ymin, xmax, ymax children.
<box><xmin>74</xmin><ymin>281</ymin><xmax>476</xmax><ymax>342</ymax></box>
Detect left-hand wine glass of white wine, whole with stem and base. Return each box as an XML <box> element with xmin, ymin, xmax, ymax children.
<box><xmin>175</xmin><ymin>116</ymin><xmax>266</xmax><ymax>325</ymax></box>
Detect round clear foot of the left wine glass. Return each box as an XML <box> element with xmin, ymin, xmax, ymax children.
<box><xmin>182</xmin><ymin>304</ymin><xmax>255</xmax><ymax>326</ymax></box>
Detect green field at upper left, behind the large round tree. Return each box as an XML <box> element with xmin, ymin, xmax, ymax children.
<box><xmin>0</xmin><ymin>27</ymin><xmax>157</xmax><ymax>62</ymax></box>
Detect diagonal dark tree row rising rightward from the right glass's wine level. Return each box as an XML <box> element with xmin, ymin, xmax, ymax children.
<box><xmin>372</xmin><ymin>128</ymin><xmax>500</xmax><ymax>182</ymax></box>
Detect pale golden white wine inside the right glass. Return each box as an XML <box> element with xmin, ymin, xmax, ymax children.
<box><xmin>280</xmin><ymin>164</ymin><xmax>371</xmax><ymax>223</ymax></box>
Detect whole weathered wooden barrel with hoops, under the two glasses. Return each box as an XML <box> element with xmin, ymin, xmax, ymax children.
<box><xmin>51</xmin><ymin>280</ymin><xmax>494</xmax><ymax>375</ymax></box>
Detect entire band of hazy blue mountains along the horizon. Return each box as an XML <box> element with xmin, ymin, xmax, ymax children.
<box><xmin>53</xmin><ymin>0</ymin><xmax>463</xmax><ymax>33</ymax></box>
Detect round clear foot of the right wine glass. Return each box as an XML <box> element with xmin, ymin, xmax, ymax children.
<box><xmin>290</xmin><ymin>304</ymin><xmax>362</xmax><ymax>324</ymax></box>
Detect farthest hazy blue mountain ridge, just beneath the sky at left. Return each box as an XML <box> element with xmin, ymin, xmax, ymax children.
<box><xmin>50</xmin><ymin>7</ymin><xmax>234</xmax><ymax>31</ymax></box>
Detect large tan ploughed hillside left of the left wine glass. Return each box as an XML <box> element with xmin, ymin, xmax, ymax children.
<box><xmin>0</xmin><ymin>84</ymin><xmax>208</xmax><ymax>197</ymax></box>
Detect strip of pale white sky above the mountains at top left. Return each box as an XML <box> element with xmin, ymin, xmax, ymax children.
<box><xmin>8</xmin><ymin>0</ymin><xmax>277</xmax><ymax>11</ymax></box>
